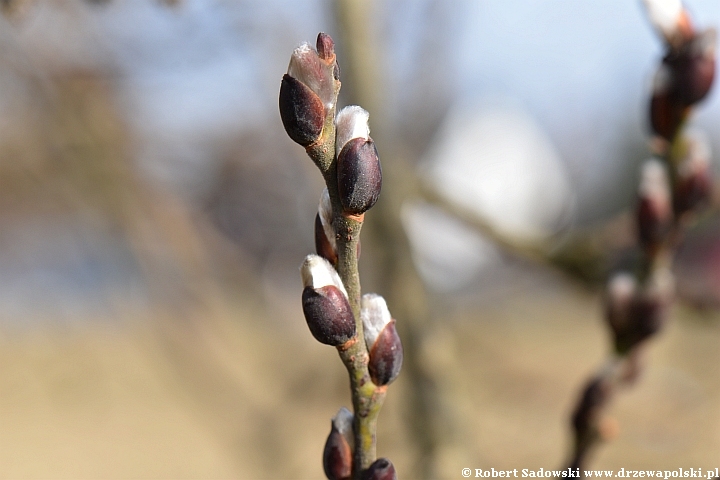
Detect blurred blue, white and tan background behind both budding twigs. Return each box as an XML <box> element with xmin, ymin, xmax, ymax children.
<box><xmin>0</xmin><ymin>0</ymin><xmax>720</xmax><ymax>479</ymax></box>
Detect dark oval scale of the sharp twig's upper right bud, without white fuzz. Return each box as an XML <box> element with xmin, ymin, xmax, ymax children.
<box><xmin>337</xmin><ymin>138</ymin><xmax>382</xmax><ymax>215</ymax></box>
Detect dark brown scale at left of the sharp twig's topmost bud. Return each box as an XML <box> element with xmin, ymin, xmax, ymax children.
<box><xmin>280</xmin><ymin>74</ymin><xmax>325</xmax><ymax>147</ymax></box>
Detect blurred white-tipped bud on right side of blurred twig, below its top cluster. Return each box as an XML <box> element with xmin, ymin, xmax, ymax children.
<box><xmin>673</xmin><ymin>130</ymin><xmax>713</xmax><ymax>215</ymax></box>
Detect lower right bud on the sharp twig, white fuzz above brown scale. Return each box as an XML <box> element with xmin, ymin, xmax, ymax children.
<box><xmin>360</xmin><ymin>293</ymin><xmax>403</xmax><ymax>386</ymax></box>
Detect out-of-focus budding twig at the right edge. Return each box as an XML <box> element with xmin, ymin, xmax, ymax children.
<box><xmin>570</xmin><ymin>0</ymin><xmax>715</xmax><ymax>472</ymax></box>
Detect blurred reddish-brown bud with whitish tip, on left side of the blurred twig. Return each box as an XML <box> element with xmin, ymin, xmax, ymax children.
<box><xmin>637</xmin><ymin>160</ymin><xmax>673</xmax><ymax>249</ymax></box>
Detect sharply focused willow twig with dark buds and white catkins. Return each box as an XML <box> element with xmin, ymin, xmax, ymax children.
<box><xmin>280</xmin><ymin>33</ymin><xmax>403</xmax><ymax>480</ymax></box>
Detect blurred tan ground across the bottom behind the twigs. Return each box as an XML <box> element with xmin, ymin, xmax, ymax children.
<box><xmin>0</xmin><ymin>274</ymin><xmax>720</xmax><ymax>479</ymax></box>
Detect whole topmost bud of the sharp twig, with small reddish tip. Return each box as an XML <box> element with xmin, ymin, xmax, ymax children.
<box><xmin>280</xmin><ymin>33</ymin><xmax>337</xmax><ymax>147</ymax></box>
